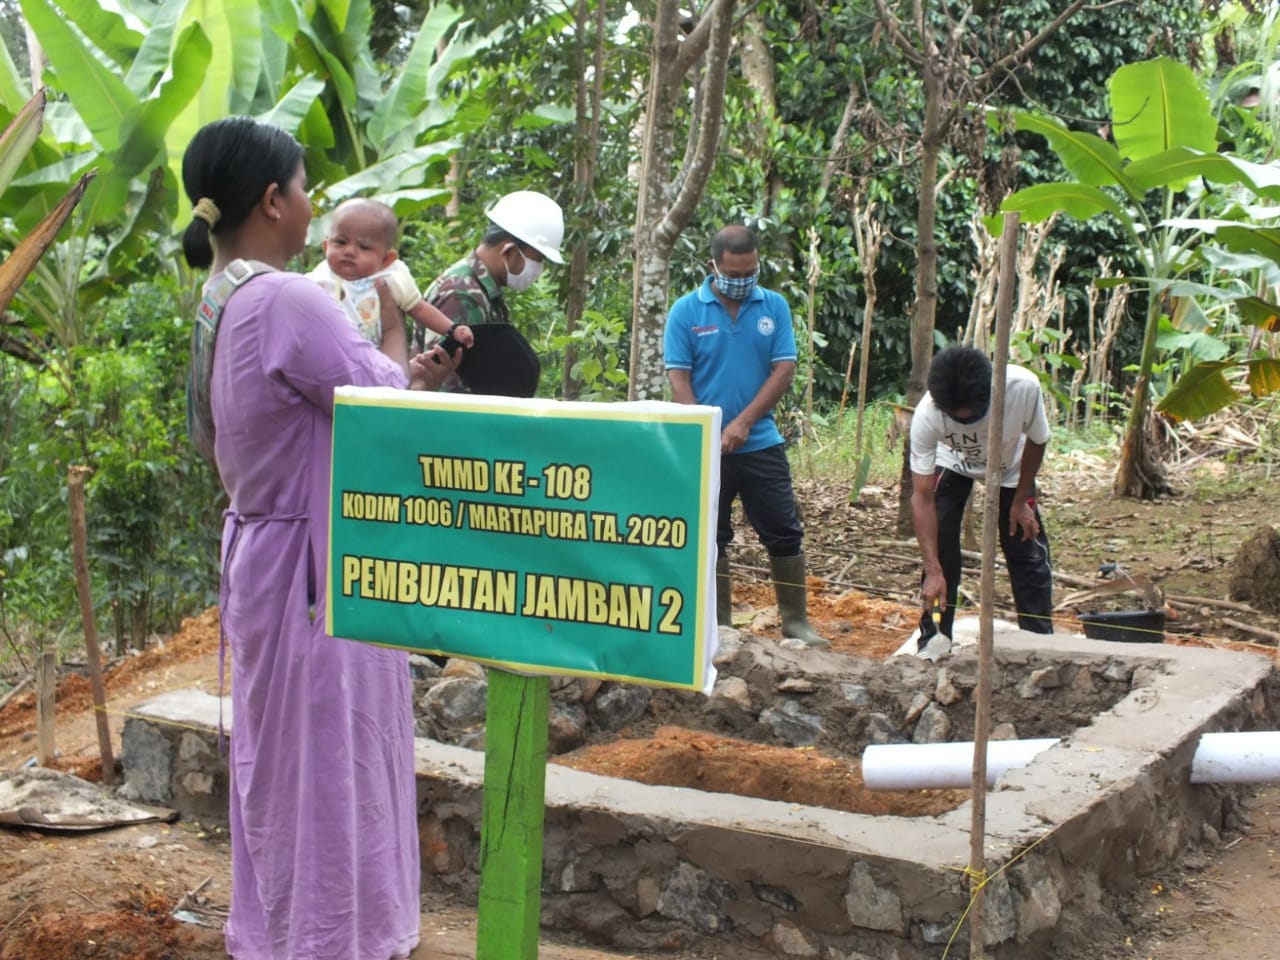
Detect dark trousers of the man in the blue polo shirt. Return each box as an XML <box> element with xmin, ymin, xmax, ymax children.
<box><xmin>716</xmin><ymin>443</ymin><xmax>804</xmax><ymax>557</ymax></box>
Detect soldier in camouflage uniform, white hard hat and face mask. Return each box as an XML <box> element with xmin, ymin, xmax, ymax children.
<box><xmin>413</xmin><ymin>189</ymin><xmax>564</xmax><ymax>349</ymax></box>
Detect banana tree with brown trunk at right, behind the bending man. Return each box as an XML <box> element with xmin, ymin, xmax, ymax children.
<box><xmin>991</xmin><ymin>58</ymin><xmax>1280</xmax><ymax>498</ymax></box>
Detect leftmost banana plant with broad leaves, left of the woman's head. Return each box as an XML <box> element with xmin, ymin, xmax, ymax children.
<box><xmin>0</xmin><ymin>0</ymin><xmax>211</xmax><ymax>358</ymax></box>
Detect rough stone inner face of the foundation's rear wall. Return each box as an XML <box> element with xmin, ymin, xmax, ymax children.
<box><xmin>412</xmin><ymin>630</ymin><xmax>1141</xmax><ymax>759</ymax></box>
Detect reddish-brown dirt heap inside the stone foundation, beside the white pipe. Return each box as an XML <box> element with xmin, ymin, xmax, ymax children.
<box><xmin>552</xmin><ymin>726</ymin><xmax>969</xmax><ymax>817</ymax></box>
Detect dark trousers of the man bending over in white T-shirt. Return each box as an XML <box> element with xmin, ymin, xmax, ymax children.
<box><xmin>920</xmin><ymin>470</ymin><xmax>1053</xmax><ymax>637</ymax></box>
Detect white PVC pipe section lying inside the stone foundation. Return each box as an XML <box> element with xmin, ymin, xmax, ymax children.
<box><xmin>863</xmin><ymin>737</ymin><xmax>1057</xmax><ymax>790</ymax></box>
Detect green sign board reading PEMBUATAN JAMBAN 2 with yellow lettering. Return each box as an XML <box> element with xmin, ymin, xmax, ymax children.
<box><xmin>326</xmin><ymin>387</ymin><xmax>719</xmax><ymax>689</ymax></box>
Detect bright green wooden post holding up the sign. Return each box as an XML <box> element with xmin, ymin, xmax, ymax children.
<box><xmin>476</xmin><ymin>669</ymin><xmax>550</xmax><ymax>960</ymax></box>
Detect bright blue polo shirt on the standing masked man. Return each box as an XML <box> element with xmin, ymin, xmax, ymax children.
<box><xmin>663</xmin><ymin>276</ymin><xmax>796</xmax><ymax>453</ymax></box>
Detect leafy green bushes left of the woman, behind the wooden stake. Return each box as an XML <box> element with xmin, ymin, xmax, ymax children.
<box><xmin>0</xmin><ymin>282</ymin><xmax>218</xmax><ymax>645</ymax></box>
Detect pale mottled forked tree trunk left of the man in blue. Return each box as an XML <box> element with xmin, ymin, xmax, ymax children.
<box><xmin>627</xmin><ymin>0</ymin><xmax>735</xmax><ymax>399</ymax></box>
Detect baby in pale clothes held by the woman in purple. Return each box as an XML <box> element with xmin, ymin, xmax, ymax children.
<box><xmin>307</xmin><ymin>198</ymin><xmax>475</xmax><ymax>347</ymax></box>
